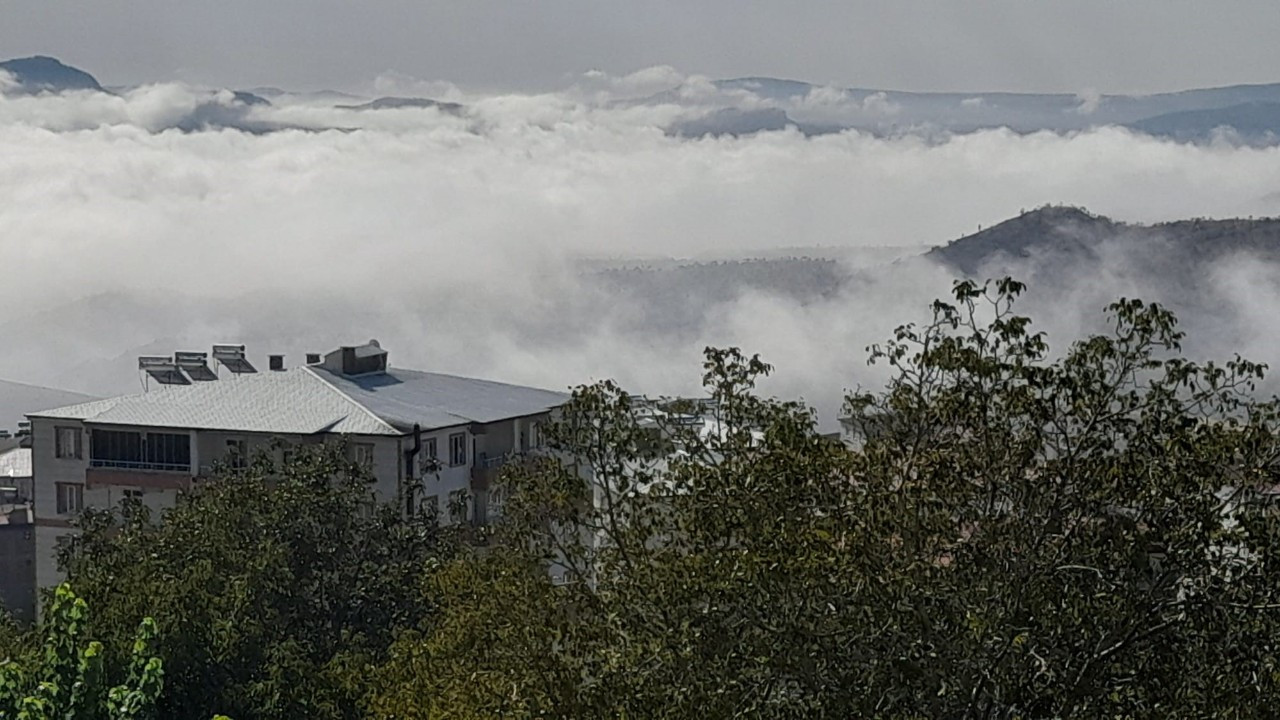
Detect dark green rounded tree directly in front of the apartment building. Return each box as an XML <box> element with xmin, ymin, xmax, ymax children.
<box><xmin>63</xmin><ymin>443</ymin><xmax>449</xmax><ymax>720</ymax></box>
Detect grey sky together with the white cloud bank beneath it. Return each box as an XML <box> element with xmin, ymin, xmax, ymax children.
<box><xmin>0</xmin><ymin>0</ymin><xmax>1280</xmax><ymax>421</ymax></box>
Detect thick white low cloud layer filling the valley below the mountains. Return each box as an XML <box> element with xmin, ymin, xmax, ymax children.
<box><xmin>0</xmin><ymin>73</ymin><xmax>1280</xmax><ymax>422</ymax></box>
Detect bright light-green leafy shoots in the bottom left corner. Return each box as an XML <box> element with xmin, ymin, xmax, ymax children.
<box><xmin>0</xmin><ymin>584</ymin><xmax>164</xmax><ymax>720</ymax></box>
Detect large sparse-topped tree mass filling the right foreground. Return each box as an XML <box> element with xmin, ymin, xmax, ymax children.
<box><xmin>376</xmin><ymin>281</ymin><xmax>1280</xmax><ymax>719</ymax></box>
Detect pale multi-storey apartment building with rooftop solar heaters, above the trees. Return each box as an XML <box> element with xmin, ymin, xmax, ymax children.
<box><xmin>29</xmin><ymin>341</ymin><xmax>567</xmax><ymax>588</ymax></box>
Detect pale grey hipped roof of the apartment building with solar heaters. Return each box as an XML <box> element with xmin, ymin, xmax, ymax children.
<box><xmin>31</xmin><ymin>366</ymin><xmax>567</xmax><ymax>436</ymax></box>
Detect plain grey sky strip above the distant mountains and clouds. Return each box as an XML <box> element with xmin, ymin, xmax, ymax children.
<box><xmin>0</xmin><ymin>0</ymin><xmax>1280</xmax><ymax>94</ymax></box>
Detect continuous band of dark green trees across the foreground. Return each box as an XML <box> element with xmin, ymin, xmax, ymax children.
<box><xmin>2</xmin><ymin>281</ymin><xmax>1280</xmax><ymax>719</ymax></box>
